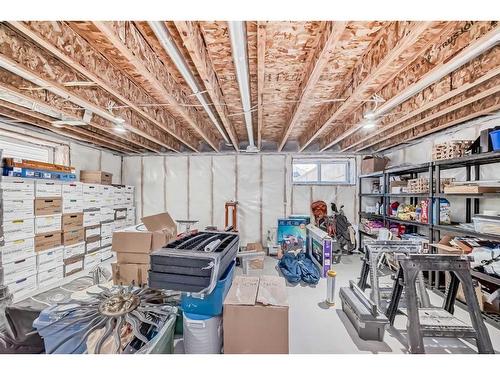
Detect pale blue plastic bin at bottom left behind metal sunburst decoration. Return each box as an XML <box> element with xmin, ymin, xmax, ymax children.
<box><xmin>33</xmin><ymin>305</ymin><xmax>88</xmax><ymax>354</ymax></box>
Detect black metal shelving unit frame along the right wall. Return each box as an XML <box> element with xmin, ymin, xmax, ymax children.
<box><xmin>358</xmin><ymin>151</ymin><xmax>500</xmax><ymax>327</ymax></box>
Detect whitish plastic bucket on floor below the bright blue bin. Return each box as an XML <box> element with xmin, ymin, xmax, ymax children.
<box><xmin>182</xmin><ymin>313</ymin><xmax>222</xmax><ymax>354</ymax></box>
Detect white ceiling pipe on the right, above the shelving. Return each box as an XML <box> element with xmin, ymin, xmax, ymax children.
<box><xmin>374</xmin><ymin>29</ymin><xmax>500</xmax><ymax>118</ymax></box>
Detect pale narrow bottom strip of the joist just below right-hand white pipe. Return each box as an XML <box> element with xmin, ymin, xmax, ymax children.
<box><xmin>348</xmin><ymin>62</ymin><xmax>500</xmax><ymax>152</ymax></box>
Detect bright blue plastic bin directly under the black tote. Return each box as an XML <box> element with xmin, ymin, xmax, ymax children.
<box><xmin>181</xmin><ymin>260</ymin><xmax>236</xmax><ymax>316</ymax></box>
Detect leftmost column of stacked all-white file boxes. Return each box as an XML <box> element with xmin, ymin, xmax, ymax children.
<box><xmin>0</xmin><ymin>177</ymin><xmax>37</xmax><ymax>293</ymax></box>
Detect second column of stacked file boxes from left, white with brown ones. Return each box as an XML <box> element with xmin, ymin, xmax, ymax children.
<box><xmin>34</xmin><ymin>180</ymin><xmax>64</xmax><ymax>286</ymax></box>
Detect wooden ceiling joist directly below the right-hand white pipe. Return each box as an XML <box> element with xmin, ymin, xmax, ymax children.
<box><xmin>341</xmin><ymin>47</ymin><xmax>500</xmax><ymax>151</ymax></box>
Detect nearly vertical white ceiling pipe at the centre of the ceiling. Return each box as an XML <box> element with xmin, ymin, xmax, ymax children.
<box><xmin>228</xmin><ymin>21</ymin><xmax>257</xmax><ymax>151</ymax></box>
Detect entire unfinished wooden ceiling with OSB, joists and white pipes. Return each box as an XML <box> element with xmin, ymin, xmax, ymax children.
<box><xmin>0</xmin><ymin>21</ymin><xmax>500</xmax><ymax>154</ymax></box>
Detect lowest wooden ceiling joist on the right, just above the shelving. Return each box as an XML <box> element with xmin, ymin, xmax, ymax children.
<box><xmin>376</xmin><ymin>90</ymin><xmax>500</xmax><ymax>152</ymax></box>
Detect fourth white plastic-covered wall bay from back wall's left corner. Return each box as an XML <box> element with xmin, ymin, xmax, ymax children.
<box><xmin>189</xmin><ymin>156</ymin><xmax>212</xmax><ymax>230</ymax></box>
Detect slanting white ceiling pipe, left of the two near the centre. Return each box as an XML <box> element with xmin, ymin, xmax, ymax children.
<box><xmin>148</xmin><ymin>21</ymin><xmax>231</xmax><ymax>143</ymax></box>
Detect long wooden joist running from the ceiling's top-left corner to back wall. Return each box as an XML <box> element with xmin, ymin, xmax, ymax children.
<box><xmin>9</xmin><ymin>21</ymin><xmax>197</xmax><ymax>152</ymax></box>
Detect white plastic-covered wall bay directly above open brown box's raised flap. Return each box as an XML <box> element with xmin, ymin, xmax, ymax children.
<box><xmin>142</xmin><ymin>156</ymin><xmax>165</xmax><ymax>216</ymax></box>
